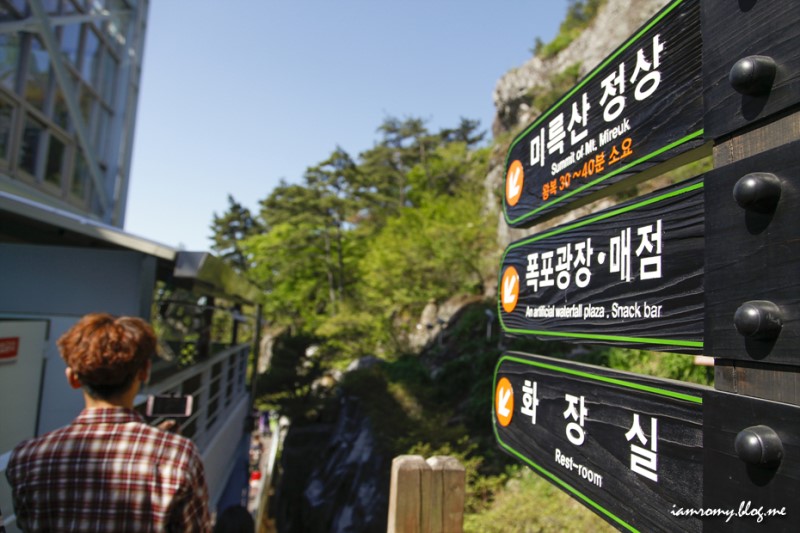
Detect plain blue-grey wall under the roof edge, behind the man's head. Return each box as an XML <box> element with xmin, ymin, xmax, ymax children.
<box><xmin>0</xmin><ymin>244</ymin><xmax>156</xmax><ymax>434</ymax></box>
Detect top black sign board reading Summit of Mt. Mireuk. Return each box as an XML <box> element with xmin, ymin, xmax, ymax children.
<box><xmin>503</xmin><ymin>0</ymin><xmax>706</xmax><ymax>227</ymax></box>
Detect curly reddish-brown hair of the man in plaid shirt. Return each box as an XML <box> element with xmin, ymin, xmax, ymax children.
<box><xmin>57</xmin><ymin>313</ymin><xmax>156</xmax><ymax>397</ymax></box>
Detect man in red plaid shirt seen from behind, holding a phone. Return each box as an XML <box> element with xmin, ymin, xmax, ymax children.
<box><xmin>6</xmin><ymin>313</ymin><xmax>211</xmax><ymax>532</ymax></box>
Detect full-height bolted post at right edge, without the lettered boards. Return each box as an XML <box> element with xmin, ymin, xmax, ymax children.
<box><xmin>702</xmin><ymin>0</ymin><xmax>800</xmax><ymax>532</ymax></box>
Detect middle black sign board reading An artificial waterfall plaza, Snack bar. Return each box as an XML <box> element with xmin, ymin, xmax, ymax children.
<box><xmin>498</xmin><ymin>177</ymin><xmax>704</xmax><ymax>353</ymax></box>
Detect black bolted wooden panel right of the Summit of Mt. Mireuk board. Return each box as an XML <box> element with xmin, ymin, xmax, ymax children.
<box><xmin>702</xmin><ymin>0</ymin><xmax>800</xmax><ymax>139</ymax></box>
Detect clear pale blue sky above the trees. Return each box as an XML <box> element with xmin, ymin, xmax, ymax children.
<box><xmin>125</xmin><ymin>0</ymin><xmax>568</xmax><ymax>250</ymax></box>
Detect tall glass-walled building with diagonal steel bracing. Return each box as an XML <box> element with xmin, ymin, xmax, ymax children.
<box><xmin>0</xmin><ymin>0</ymin><xmax>148</xmax><ymax>224</ymax></box>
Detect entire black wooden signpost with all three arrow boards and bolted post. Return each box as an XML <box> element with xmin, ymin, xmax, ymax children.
<box><xmin>493</xmin><ymin>0</ymin><xmax>800</xmax><ymax>532</ymax></box>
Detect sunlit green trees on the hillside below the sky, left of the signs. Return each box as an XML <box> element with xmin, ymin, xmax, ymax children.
<box><xmin>206</xmin><ymin>117</ymin><xmax>493</xmax><ymax>364</ymax></box>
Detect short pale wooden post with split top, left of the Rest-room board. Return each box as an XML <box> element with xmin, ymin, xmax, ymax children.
<box><xmin>386</xmin><ymin>455</ymin><xmax>466</xmax><ymax>533</ymax></box>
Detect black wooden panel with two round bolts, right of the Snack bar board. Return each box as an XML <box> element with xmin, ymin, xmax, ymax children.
<box><xmin>705</xmin><ymin>142</ymin><xmax>800</xmax><ymax>366</ymax></box>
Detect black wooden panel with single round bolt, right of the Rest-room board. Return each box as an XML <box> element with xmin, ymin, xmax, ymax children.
<box><xmin>703</xmin><ymin>391</ymin><xmax>800</xmax><ymax>532</ymax></box>
